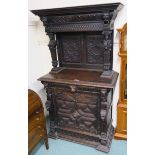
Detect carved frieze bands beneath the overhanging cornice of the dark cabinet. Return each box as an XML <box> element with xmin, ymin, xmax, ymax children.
<box><xmin>40</xmin><ymin>12</ymin><xmax>113</xmax><ymax>33</ymax></box>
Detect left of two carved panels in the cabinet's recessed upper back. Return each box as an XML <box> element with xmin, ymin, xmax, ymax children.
<box><xmin>62</xmin><ymin>35</ymin><xmax>81</xmax><ymax>63</ymax></box>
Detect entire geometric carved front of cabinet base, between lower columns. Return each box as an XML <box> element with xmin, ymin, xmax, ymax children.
<box><xmin>55</xmin><ymin>88</ymin><xmax>99</xmax><ymax>134</ymax></box>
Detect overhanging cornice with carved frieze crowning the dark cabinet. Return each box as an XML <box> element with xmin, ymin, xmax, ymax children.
<box><xmin>32</xmin><ymin>3</ymin><xmax>122</xmax><ymax>32</ymax></box>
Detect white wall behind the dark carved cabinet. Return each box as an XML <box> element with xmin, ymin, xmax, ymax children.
<box><xmin>28</xmin><ymin>0</ymin><xmax>127</xmax><ymax>126</ymax></box>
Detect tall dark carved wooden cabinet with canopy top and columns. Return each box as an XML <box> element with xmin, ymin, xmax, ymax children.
<box><xmin>32</xmin><ymin>3</ymin><xmax>122</xmax><ymax>152</ymax></box>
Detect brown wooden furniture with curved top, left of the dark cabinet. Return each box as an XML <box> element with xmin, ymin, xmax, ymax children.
<box><xmin>28</xmin><ymin>89</ymin><xmax>48</xmax><ymax>154</ymax></box>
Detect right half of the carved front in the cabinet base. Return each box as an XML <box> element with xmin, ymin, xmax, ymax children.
<box><xmin>76</xmin><ymin>92</ymin><xmax>98</xmax><ymax>133</ymax></box>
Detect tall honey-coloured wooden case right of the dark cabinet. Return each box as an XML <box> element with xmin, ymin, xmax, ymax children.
<box><xmin>115</xmin><ymin>23</ymin><xmax>127</xmax><ymax>139</ymax></box>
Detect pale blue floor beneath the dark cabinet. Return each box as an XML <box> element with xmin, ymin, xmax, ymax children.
<box><xmin>31</xmin><ymin>139</ymin><xmax>127</xmax><ymax>155</ymax></box>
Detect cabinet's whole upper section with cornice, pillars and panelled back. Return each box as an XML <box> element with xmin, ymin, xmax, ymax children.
<box><xmin>32</xmin><ymin>3</ymin><xmax>122</xmax><ymax>78</ymax></box>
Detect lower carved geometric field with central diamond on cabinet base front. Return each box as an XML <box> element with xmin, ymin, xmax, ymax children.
<box><xmin>56</xmin><ymin>100</ymin><xmax>97</xmax><ymax>133</ymax></box>
